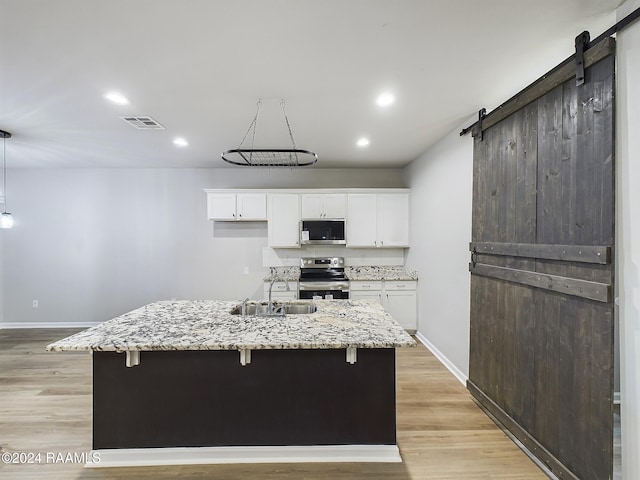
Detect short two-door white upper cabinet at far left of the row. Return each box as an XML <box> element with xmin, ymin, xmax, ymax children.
<box><xmin>207</xmin><ymin>193</ymin><xmax>267</xmax><ymax>221</ymax></box>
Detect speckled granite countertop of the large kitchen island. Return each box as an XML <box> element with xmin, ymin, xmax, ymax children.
<box><xmin>47</xmin><ymin>300</ymin><xmax>415</xmax><ymax>351</ymax></box>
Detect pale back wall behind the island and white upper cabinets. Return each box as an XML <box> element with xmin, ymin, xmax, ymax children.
<box><xmin>0</xmin><ymin>168</ymin><xmax>404</xmax><ymax>326</ymax></box>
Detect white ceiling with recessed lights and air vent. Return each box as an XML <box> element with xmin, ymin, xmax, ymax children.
<box><xmin>0</xmin><ymin>0</ymin><xmax>622</xmax><ymax>168</ymax></box>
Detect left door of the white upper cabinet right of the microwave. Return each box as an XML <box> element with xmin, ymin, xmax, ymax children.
<box><xmin>347</xmin><ymin>193</ymin><xmax>377</xmax><ymax>247</ymax></box>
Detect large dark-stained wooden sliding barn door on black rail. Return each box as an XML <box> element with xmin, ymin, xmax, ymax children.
<box><xmin>468</xmin><ymin>39</ymin><xmax>614</xmax><ymax>480</ymax></box>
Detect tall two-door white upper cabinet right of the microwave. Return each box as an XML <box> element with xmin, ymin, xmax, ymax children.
<box><xmin>347</xmin><ymin>193</ymin><xmax>409</xmax><ymax>247</ymax></box>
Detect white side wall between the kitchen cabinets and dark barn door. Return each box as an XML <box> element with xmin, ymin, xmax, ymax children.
<box><xmin>405</xmin><ymin>117</ymin><xmax>475</xmax><ymax>380</ymax></box>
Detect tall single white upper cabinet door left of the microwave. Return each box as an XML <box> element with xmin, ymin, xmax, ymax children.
<box><xmin>267</xmin><ymin>193</ymin><xmax>300</xmax><ymax>248</ymax></box>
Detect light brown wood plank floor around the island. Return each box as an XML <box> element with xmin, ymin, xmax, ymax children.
<box><xmin>0</xmin><ymin>329</ymin><xmax>547</xmax><ymax>480</ymax></box>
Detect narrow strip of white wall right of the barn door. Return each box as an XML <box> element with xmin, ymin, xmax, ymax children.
<box><xmin>616</xmin><ymin>0</ymin><xmax>640</xmax><ymax>479</ymax></box>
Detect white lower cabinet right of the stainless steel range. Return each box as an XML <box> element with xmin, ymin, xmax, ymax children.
<box><xmin>349</xmin><ymin>280</ymin><xmax>418</xmax><ymax>332</ymax></box>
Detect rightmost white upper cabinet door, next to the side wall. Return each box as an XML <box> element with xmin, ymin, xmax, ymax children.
<box><xmin>377</xmin><ymin>193</ymin><xmax>409</xmax><ymax>247</ymax></box>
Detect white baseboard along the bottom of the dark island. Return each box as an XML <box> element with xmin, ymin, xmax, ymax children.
<box><xmin>85</xmin><ymin>445</ymin><xmax>402</xmax><ymax>468</ymax></box>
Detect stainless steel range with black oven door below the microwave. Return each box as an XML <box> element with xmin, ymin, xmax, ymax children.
<box><xmin>298</xmin><ymin>257</ymin><xmax>349</xmax><ymax>300</ymax></box>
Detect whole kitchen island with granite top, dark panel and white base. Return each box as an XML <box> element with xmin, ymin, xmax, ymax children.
<box><xmin>47</xmin><ymin>300</ymin><xmax>415</xmax><ymax>466</ymax></box>
